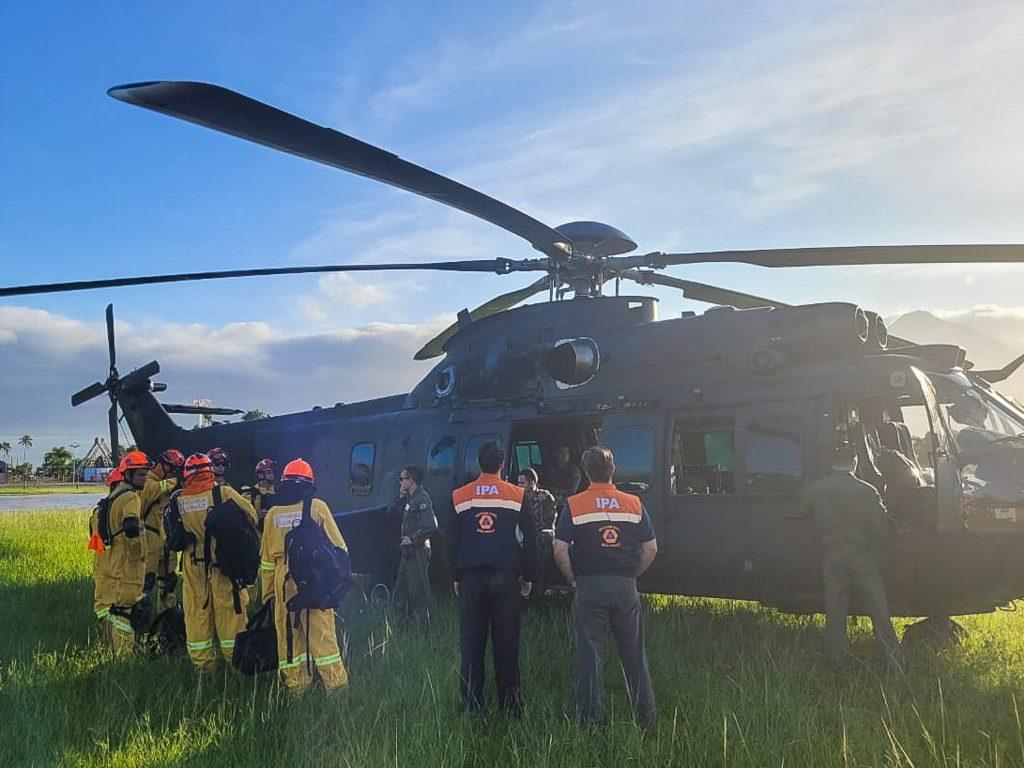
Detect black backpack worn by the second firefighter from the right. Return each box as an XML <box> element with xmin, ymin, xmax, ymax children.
<box><xmin>203</xmin><ymin>485</ymin><xmax>260</xmax><ymax>613</ymax></box>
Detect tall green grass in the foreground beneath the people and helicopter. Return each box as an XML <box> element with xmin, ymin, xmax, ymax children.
<box><xmin>0</xmin><ymin>510</ymin><xmax>1024</xmax><ymax>768</ymax></box>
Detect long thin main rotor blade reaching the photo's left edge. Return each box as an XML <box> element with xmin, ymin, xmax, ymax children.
<box><xmin>0</xmin><ymin>259</ymin><xmax>547</xmax><ymax>296</ymax></box>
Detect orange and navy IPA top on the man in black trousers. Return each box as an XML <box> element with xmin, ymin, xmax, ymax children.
<box><xmin>452</xmin><ymin>473</ymin><xmax>537</xmax><ymax>581</ymax></box>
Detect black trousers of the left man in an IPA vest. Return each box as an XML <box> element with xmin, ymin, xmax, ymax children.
<box><xmin>459</xmin><ymin>568</ymin><xmax>522</xmax><ymax>712</ymax></box>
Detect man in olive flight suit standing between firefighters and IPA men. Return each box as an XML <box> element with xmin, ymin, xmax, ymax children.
<box><xmin>392</xmin><ymin>464</ymin><xmax>437</xmax><ymax>631</ymax></box>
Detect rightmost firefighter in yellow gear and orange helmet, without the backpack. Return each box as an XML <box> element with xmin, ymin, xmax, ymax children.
<box><xmin>260</xmin><ymin>459</ymin><xmax>348</xmax><ymax>694</ymax></box>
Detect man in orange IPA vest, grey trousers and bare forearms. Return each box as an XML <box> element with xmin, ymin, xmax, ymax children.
<box><xmin>554</xmin><ymin>445</ymin><xmax>657</xmax><ymax>728</ymax></box>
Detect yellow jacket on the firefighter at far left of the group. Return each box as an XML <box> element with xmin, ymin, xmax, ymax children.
<box><xmin>89</xmin><ymin>482</ymin><xmax>145</xmax><ymax>610</ymax></box>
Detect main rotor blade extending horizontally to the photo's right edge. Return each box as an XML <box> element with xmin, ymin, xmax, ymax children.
<box><xmin>606</xmin><ymin>245</ymin><xmax>1024</xmax><ymax>269</ymax></box>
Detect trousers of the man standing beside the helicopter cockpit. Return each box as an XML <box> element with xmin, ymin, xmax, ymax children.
<box><xmin>821</xmin><ymin>551</ymin><xmax>902</xmax><ymax>670</ymax></box>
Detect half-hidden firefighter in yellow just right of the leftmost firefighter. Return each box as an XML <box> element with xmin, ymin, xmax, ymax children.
<box><xmin>139</xmin><ymin>449</ymin><xmax>185</xmax><ymax>613</ymax></box>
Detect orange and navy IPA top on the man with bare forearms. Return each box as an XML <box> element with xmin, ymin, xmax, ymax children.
<box><xmin>555</xmin><ymin>482</ymin><xmax>654</xmax><ymax>577</ymax></box>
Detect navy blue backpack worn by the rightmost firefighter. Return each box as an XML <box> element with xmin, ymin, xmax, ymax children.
<box><xmin>285</xmin><ymin>495</ymin><xmax>352</xmax><ymax>612</ymax></box>
